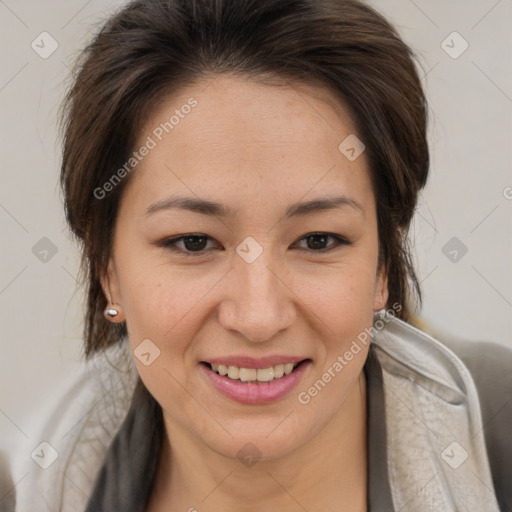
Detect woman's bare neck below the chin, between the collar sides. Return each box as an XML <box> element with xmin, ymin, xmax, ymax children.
<box><xmin>146</xmin><ymin>371</ymin><xmax>367</xmax><ymax>512</ymax></box>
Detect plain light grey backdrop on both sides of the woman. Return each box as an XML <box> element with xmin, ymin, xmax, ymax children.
<box><xmin>0</xmin><ymin>0</ymin><xmax>512</xmax><ymax>444</ymax></box>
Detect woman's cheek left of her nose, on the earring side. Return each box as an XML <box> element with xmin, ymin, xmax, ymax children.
<box><xmin>118</xmin><ymin>264</ymin><xmax>218</xmax><ymax>412</ymax></box>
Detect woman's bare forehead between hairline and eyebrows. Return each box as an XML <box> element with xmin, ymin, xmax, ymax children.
<box><xmin>124</xmin><ymin>76</ymin><xmax>373</xmax><ymax>220</ymax></box>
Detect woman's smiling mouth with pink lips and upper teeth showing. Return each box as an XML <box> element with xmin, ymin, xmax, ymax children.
<box><xmin>199</xmin><ymin>358</ymin><xmax>312</xmax><ymax>405</ymax></box>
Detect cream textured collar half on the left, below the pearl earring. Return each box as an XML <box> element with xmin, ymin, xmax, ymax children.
<box><xmin>8</xmin><ymin>344</ymin><xmax>137</xmax><ymax>512</ymax></box>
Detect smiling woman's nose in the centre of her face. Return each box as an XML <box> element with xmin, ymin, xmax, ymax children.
<box><xmin>218</xmin><ymin>251</ymin><xmax>296</xmax><ymax>342</ymax></box>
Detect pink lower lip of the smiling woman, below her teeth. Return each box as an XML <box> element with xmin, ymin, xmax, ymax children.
<box><xmin>200</xmin><ymin>360</ymin><xmax>311</xmax><ymax>405</ymax></box>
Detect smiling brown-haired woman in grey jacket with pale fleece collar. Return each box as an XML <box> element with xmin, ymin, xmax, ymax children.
<box><xmin>5</xmin><ymin>0</ymin><xmax>512</xmax><ymax>512</ymax></box>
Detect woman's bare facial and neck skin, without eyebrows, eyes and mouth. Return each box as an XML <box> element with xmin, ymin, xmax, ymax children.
<box><xmin>102</xmin><ymin>75</ymin><xmax>388</xmax><ymax>512</ymax></box>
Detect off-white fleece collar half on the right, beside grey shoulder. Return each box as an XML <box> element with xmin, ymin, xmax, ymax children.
<box><xmin>373</xmin><ymin>318</ymin><xmax>499</xmax><ymax>512</ymax></box>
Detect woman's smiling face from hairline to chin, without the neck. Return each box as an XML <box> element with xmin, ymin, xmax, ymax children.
<box><xmin>102</xmin><ymin>76</ymin><xmax>387</xmax><ymax>459</ymax></box>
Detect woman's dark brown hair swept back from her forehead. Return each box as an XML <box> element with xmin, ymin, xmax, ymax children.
<box><xmin>60</xmin><ymin>0</ymin><xmax>429</xmax><ymax>357</ymax></box>
